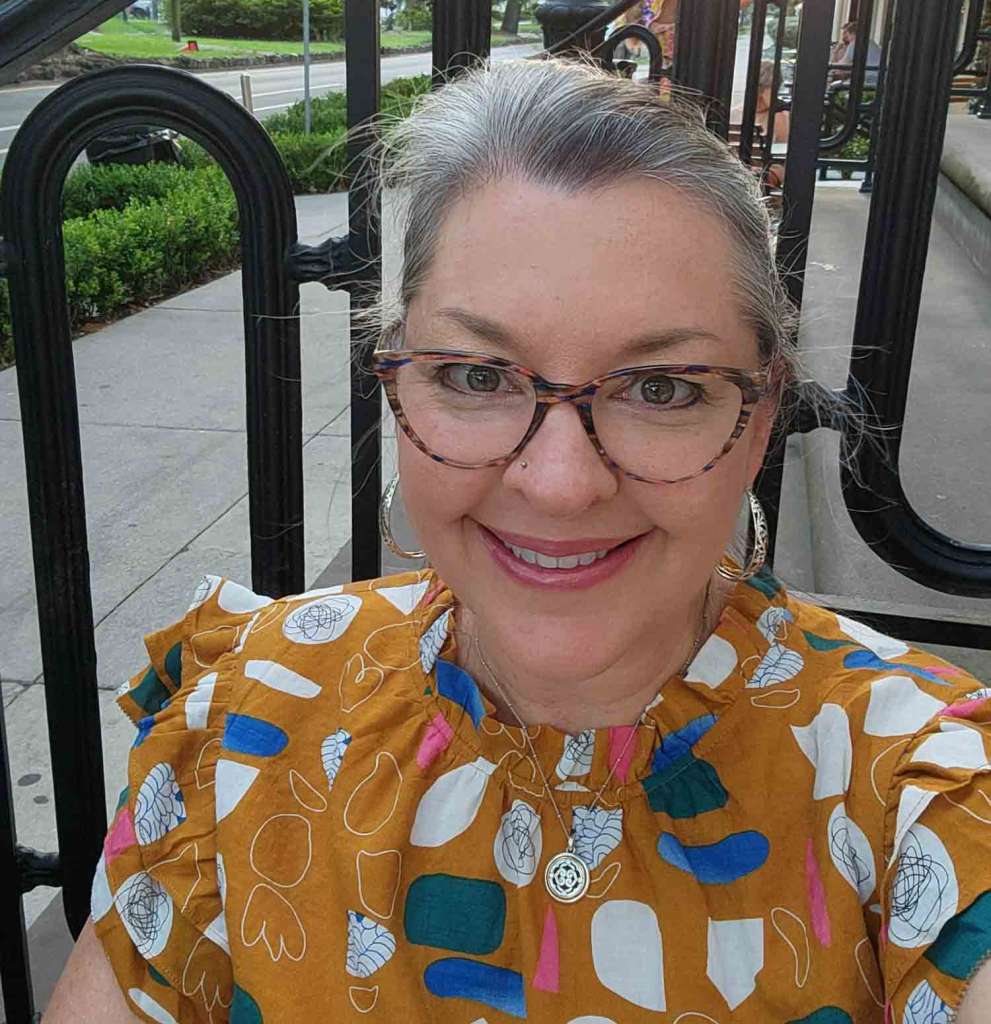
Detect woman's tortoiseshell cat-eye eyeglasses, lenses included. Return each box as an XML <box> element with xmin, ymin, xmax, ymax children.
<box><xmin>373</xmin><ymin>349</ymin><xmax>768</xmax><ymax>483</ymax></box>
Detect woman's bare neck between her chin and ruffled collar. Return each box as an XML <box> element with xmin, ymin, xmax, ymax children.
<box><xmin>458</xmin><ymin>585</ymin><xmax>726</xmax><ymax>735</ymax></box>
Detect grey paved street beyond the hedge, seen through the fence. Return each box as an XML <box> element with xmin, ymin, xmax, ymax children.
<box><xmin>0</xmin><ymin>43</ymin><xmax>540</xmax><ymax>160</ymax></box>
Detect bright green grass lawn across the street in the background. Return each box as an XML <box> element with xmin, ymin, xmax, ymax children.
<box><xmin>77</xmin><ymin>17</ymin><xmax>530</xmax><ymax>60</ymax></box>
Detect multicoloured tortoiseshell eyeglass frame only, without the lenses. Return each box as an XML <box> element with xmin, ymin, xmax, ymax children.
<box><xmin>372</xmin><ymin>348</ymin><xmax>771</xmax><ymax>483</ymax></box>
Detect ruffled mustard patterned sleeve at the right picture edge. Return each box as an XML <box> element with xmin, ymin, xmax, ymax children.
<box><xmin>880</xmin><ymin>690</ymin><xmax>991</xmax><ymax>1024</ymax></box>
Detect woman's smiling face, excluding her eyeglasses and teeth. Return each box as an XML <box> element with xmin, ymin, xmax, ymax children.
<box><xmin>399</xmin><ymin>179</ymin><xmax>774</xmax><ymax>681</ymax></box>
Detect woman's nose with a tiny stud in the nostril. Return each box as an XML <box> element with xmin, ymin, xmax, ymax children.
<box><xmin>504</xmin><ymin>402</ymin><xmax>619</xmax><ymax>518</ymax></box>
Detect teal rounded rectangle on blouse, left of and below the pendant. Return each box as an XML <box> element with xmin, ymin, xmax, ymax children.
<box><xmin>403</xmin><ymin>874</ymin><xmax>506</xmax><ymax>954</ymax></box>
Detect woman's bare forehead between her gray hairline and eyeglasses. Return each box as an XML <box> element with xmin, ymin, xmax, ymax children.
<box><xmin>410</xmin><ymin>179</ymin><xmax>757</xmax><ymax>372</ymax></box>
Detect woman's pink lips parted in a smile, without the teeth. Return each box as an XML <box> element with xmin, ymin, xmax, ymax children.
<box><xmin>477</xmin><ymin>523</ymin><xmax>650</xmax><ymax>591</ymax></box>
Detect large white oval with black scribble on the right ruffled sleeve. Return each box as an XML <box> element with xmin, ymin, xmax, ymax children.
<box><xmin>888</xmin><ymin>822</ymin><xmax>960</xmax><ymax>949</ymax></box>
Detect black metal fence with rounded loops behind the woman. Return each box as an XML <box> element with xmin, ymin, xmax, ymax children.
<box><xmin>0</xmin><ymin>0</ymin><xmax>991</xmax><ymax>1024</ymax></box>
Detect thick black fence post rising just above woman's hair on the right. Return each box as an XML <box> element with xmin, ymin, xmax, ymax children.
<box><xmin>675</xmin><ymin>0</ymin><xmax>740</xmax><ymax>138</ymax></box>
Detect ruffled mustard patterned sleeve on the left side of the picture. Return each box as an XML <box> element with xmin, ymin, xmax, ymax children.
<box><xmin>91</xmin><ymin>577</ymin><xmax>268</xmax><ymax>1024</ymax></box>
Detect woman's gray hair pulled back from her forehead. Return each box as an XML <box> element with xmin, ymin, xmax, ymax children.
<box><xmin>374</xmin><ymin>59</ymin><xmax>796</xmax><ymax>387</ymax></box>
